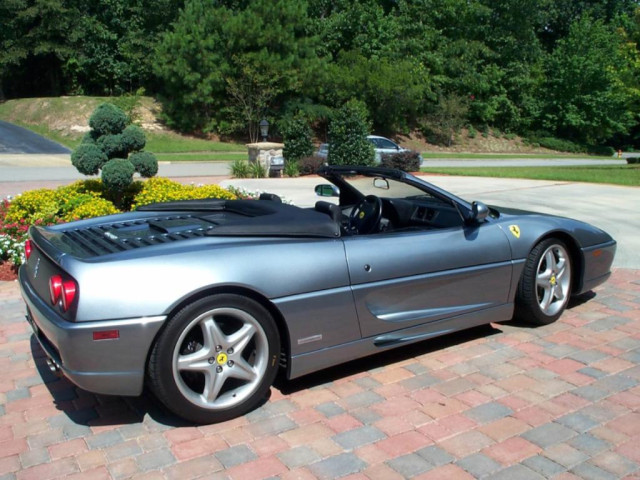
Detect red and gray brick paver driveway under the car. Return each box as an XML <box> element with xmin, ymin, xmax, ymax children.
<box><xmin>0</xmin><ymin>269</ymin><xmax>640</xmax><ymax>480</ymax></box>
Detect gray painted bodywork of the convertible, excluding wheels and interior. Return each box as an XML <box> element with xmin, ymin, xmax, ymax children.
<box><xmin>20</xmin><ymin>169</ymin><xmax>615</xmax><ymax>395</ymax></box>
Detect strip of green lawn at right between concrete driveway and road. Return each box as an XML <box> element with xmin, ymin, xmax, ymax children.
<box><xmin>420</xmin><ymin>165</ymin><xmax>640</xmax><ymax>187</ymax></box>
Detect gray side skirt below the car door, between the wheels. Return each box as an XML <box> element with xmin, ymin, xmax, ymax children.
<box><xmin>287</xmin><ymin>303</ymin><xmax>514</xmax><ymax>379</ymax></box>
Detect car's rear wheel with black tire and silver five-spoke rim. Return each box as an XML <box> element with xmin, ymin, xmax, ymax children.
<box><xmin>148</xmin><ymin>294</ymin><xmax>280</xmax><ymax>423</ymax></box>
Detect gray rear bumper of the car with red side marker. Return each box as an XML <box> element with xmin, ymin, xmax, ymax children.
<box><xmin>19</xmin><ymin>268</ymin><xmax>166</xmax><ymax>395</ymax></box>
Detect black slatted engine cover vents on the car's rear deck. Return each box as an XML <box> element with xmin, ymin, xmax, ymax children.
<box><xmin>65</xmin><ymin>215</ymin><xmax>215</xmax><ymax>257</ymax></box>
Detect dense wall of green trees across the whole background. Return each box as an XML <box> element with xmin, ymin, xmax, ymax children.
<box><xmin>0</xmin><ymin>0</ymin><xmax>640</xmax><ymax>150</ymax></box>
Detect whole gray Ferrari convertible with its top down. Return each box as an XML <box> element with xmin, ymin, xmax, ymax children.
<box><xmin>19</xmin><ymin>167</ymin><xmax>616</xmax><ymax>423</ymax></box>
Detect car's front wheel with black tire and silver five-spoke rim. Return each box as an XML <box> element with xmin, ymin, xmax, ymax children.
<box><xmin>516</xmin><ymin>238</ymin><xmax>572</xmax><ymax>325</ymax></box>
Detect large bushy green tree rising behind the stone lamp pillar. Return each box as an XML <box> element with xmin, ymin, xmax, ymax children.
<box><xmin>155</xmin><ymin>0</ymin><xmax>317</xmax><ymax>138</ymax></box>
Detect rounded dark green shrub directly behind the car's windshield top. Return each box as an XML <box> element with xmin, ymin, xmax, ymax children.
<box><xmin>327</xmin><ymin>101</ymin><xmax>374</xmax><ymax>165</ymax></box>
